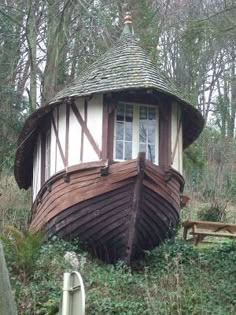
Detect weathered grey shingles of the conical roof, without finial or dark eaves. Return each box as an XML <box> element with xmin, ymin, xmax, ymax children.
<box><xmin>50</xmin><ymin>33</ymin><xmax>186</xmax><ymax>104</ymax></box>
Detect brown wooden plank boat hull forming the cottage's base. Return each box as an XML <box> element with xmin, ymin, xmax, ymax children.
<box><xmin>31</xmin><ymin>153</ymin><xmax>184</xmax><ymax>264</ymax></box>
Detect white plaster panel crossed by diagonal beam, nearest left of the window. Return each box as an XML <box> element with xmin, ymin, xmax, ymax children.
<box><xmin>83</xmin><ymin>95</ymin><xmax>103</xmax><ymax>162</ymax></box>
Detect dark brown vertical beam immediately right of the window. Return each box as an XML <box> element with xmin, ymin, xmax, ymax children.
<box><xmin>159</xmin><ymin>100</ymin><xmax>171</xmax><ymax>167</ymax></box>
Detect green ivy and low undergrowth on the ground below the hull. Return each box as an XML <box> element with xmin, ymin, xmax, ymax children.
<box><xmin>3</xmin><ymin>239</ymin><xmax>236</xmax><ymax>315</ymax></box>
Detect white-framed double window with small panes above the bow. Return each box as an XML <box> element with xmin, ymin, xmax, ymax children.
<box><xmin>114</xmin><ymin>104</ymin><xmax>158</xmax><ymax>163</ymax></box>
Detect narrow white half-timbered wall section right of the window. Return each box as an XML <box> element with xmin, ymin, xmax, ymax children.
<box><xmin>171</xmin><ymin>103</ymin><xmax>183</xmax><ymax>174</ymax></box>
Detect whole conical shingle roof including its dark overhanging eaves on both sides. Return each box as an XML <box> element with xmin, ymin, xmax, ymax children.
<box><xmin>15</xmin><ymin>17</ymin><xmax>204</xmax><ymax>188</ymax></box>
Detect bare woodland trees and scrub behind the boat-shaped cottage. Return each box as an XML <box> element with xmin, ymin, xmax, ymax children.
<box><xmin>0</xmin><ymin>0</ymin><xmax>236</xmax><ymax>314</ymax></box>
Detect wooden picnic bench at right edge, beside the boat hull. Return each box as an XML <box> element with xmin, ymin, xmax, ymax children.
<box><xmin>183</xmin><ymin>221</ymin><xmax>236</xmax><ymax>245</ymax></box>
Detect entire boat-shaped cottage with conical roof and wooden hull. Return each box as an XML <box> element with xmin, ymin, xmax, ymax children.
<box><xmin>15</xmin><ymin>14</ymin><xmax>204</xmax><ymax>263</ymax></box>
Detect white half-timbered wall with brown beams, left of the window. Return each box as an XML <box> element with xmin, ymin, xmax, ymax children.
<box><xmin>33</xmin><ymin>95</ymin><xmax>103</xmax><ymax>199</ymax></box>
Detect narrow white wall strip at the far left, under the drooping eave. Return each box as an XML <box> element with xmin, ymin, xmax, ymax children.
<box><xmin>33</xmin><ymin>136</ymin><xmax>41</xmax><ymax>201</ymax></box>
